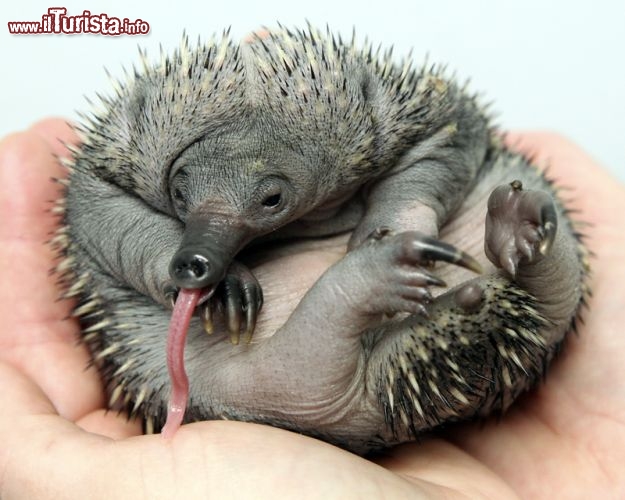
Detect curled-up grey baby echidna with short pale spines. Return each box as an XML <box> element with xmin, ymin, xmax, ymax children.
<box><xmin>55</xmin><ymin>27</ymin><xmax>588</xmax><ymax>453</ymax></box>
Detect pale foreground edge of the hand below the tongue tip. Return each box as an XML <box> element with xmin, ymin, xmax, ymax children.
<box><xmin>0</xmin><ymin>364</ymin><xmax>456</xmax><ymax>498</ymax></box>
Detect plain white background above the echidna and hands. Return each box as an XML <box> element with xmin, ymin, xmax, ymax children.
<box><xmin>0</xmin><ymin>0</ymin><xmax>625</xmax><ymax>180</ymax></box>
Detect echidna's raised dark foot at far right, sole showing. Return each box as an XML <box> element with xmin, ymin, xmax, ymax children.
<box><xmin>484</xmin><ymin>180</ymin><xmax>558</xmax><ymax>277</ymax></box>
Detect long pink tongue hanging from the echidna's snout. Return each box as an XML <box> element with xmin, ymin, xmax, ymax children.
<box><xmin>161</xmin><ymin>288</ymin><xmax>201</xmax><ymax>439</ymax></box>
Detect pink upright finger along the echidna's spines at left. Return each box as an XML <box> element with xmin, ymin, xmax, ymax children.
<box><xmin>0</xmin><ymin>125</ymin><xmax>102</xmax><ymax>418</ymax></box>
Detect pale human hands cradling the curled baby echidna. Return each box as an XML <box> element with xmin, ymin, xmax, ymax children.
<box><xmin>0</xmin><ymin>119</ymin><xmax>625</xmax><ymax>499</ymax></box>
